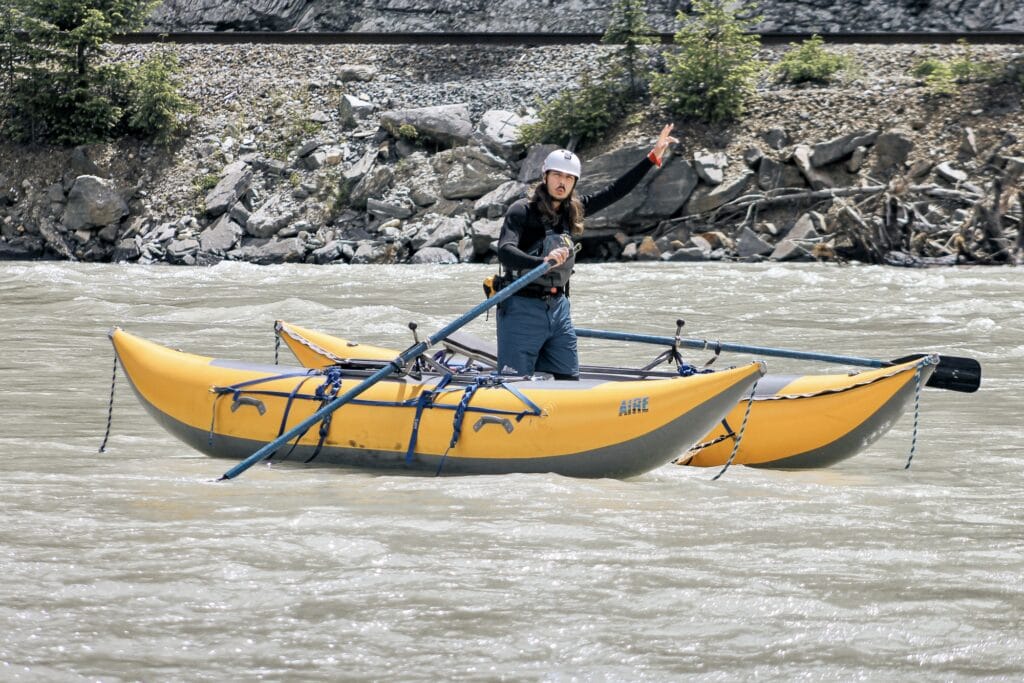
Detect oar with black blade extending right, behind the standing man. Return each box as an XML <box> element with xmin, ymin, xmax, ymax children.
<box><xmin>577</xmin><ymin>325</ymin><xmax>981</xmax><ymax>393</ymax></box>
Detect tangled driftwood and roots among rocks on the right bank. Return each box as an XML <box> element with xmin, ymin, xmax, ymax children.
<box><xmin>653</xmin><ymin>129</ymin><xmax>1024</xmax><ymax>266</ymax></box>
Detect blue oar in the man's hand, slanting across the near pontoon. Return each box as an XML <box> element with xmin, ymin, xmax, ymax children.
<box><xmin>219</xmin><ymin>261</ymin><xmax>552</xmax><ymax>480</ymax></box>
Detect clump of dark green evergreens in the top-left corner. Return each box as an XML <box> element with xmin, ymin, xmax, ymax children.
<box><xmin>0</xmin><ymin>0</ymin><xmax>187</xmax><ymax>144</ymax></box>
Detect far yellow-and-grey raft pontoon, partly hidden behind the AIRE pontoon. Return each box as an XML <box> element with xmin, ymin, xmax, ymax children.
<box><xmin>274</xmin><ymin>321</ymin><xmax>935</xmax><ymax>469</ymax></box>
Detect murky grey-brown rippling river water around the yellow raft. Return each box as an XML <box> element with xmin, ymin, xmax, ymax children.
<box><xmin>0</xmin><ymin>262</ymin><xmax>1024</xmax><ymax>681</ymax></box>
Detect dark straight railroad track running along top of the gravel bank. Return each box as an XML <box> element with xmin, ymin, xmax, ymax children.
<box><xmin>113</xmin><ymin>31</ymin><xmax>1024</xmax><ymax>47</ymax></box>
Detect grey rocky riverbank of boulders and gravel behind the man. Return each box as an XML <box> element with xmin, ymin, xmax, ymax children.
<box><xmin>0</xmin><ymin>40</ymin><xmax>1024</xmax><ymax>264</ymax></box>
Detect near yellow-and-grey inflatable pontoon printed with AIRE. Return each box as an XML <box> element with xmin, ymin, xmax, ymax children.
<box><xmin>110</xmin><ymin>329</ymin><xmax>765</xmax><ymax>477</ymax></box>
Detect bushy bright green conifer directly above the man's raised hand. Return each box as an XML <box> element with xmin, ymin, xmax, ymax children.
<box><xmin>653</xmin><ymin>0</ymin><xmax>761</xmax><ymax>123</ymax></box>
